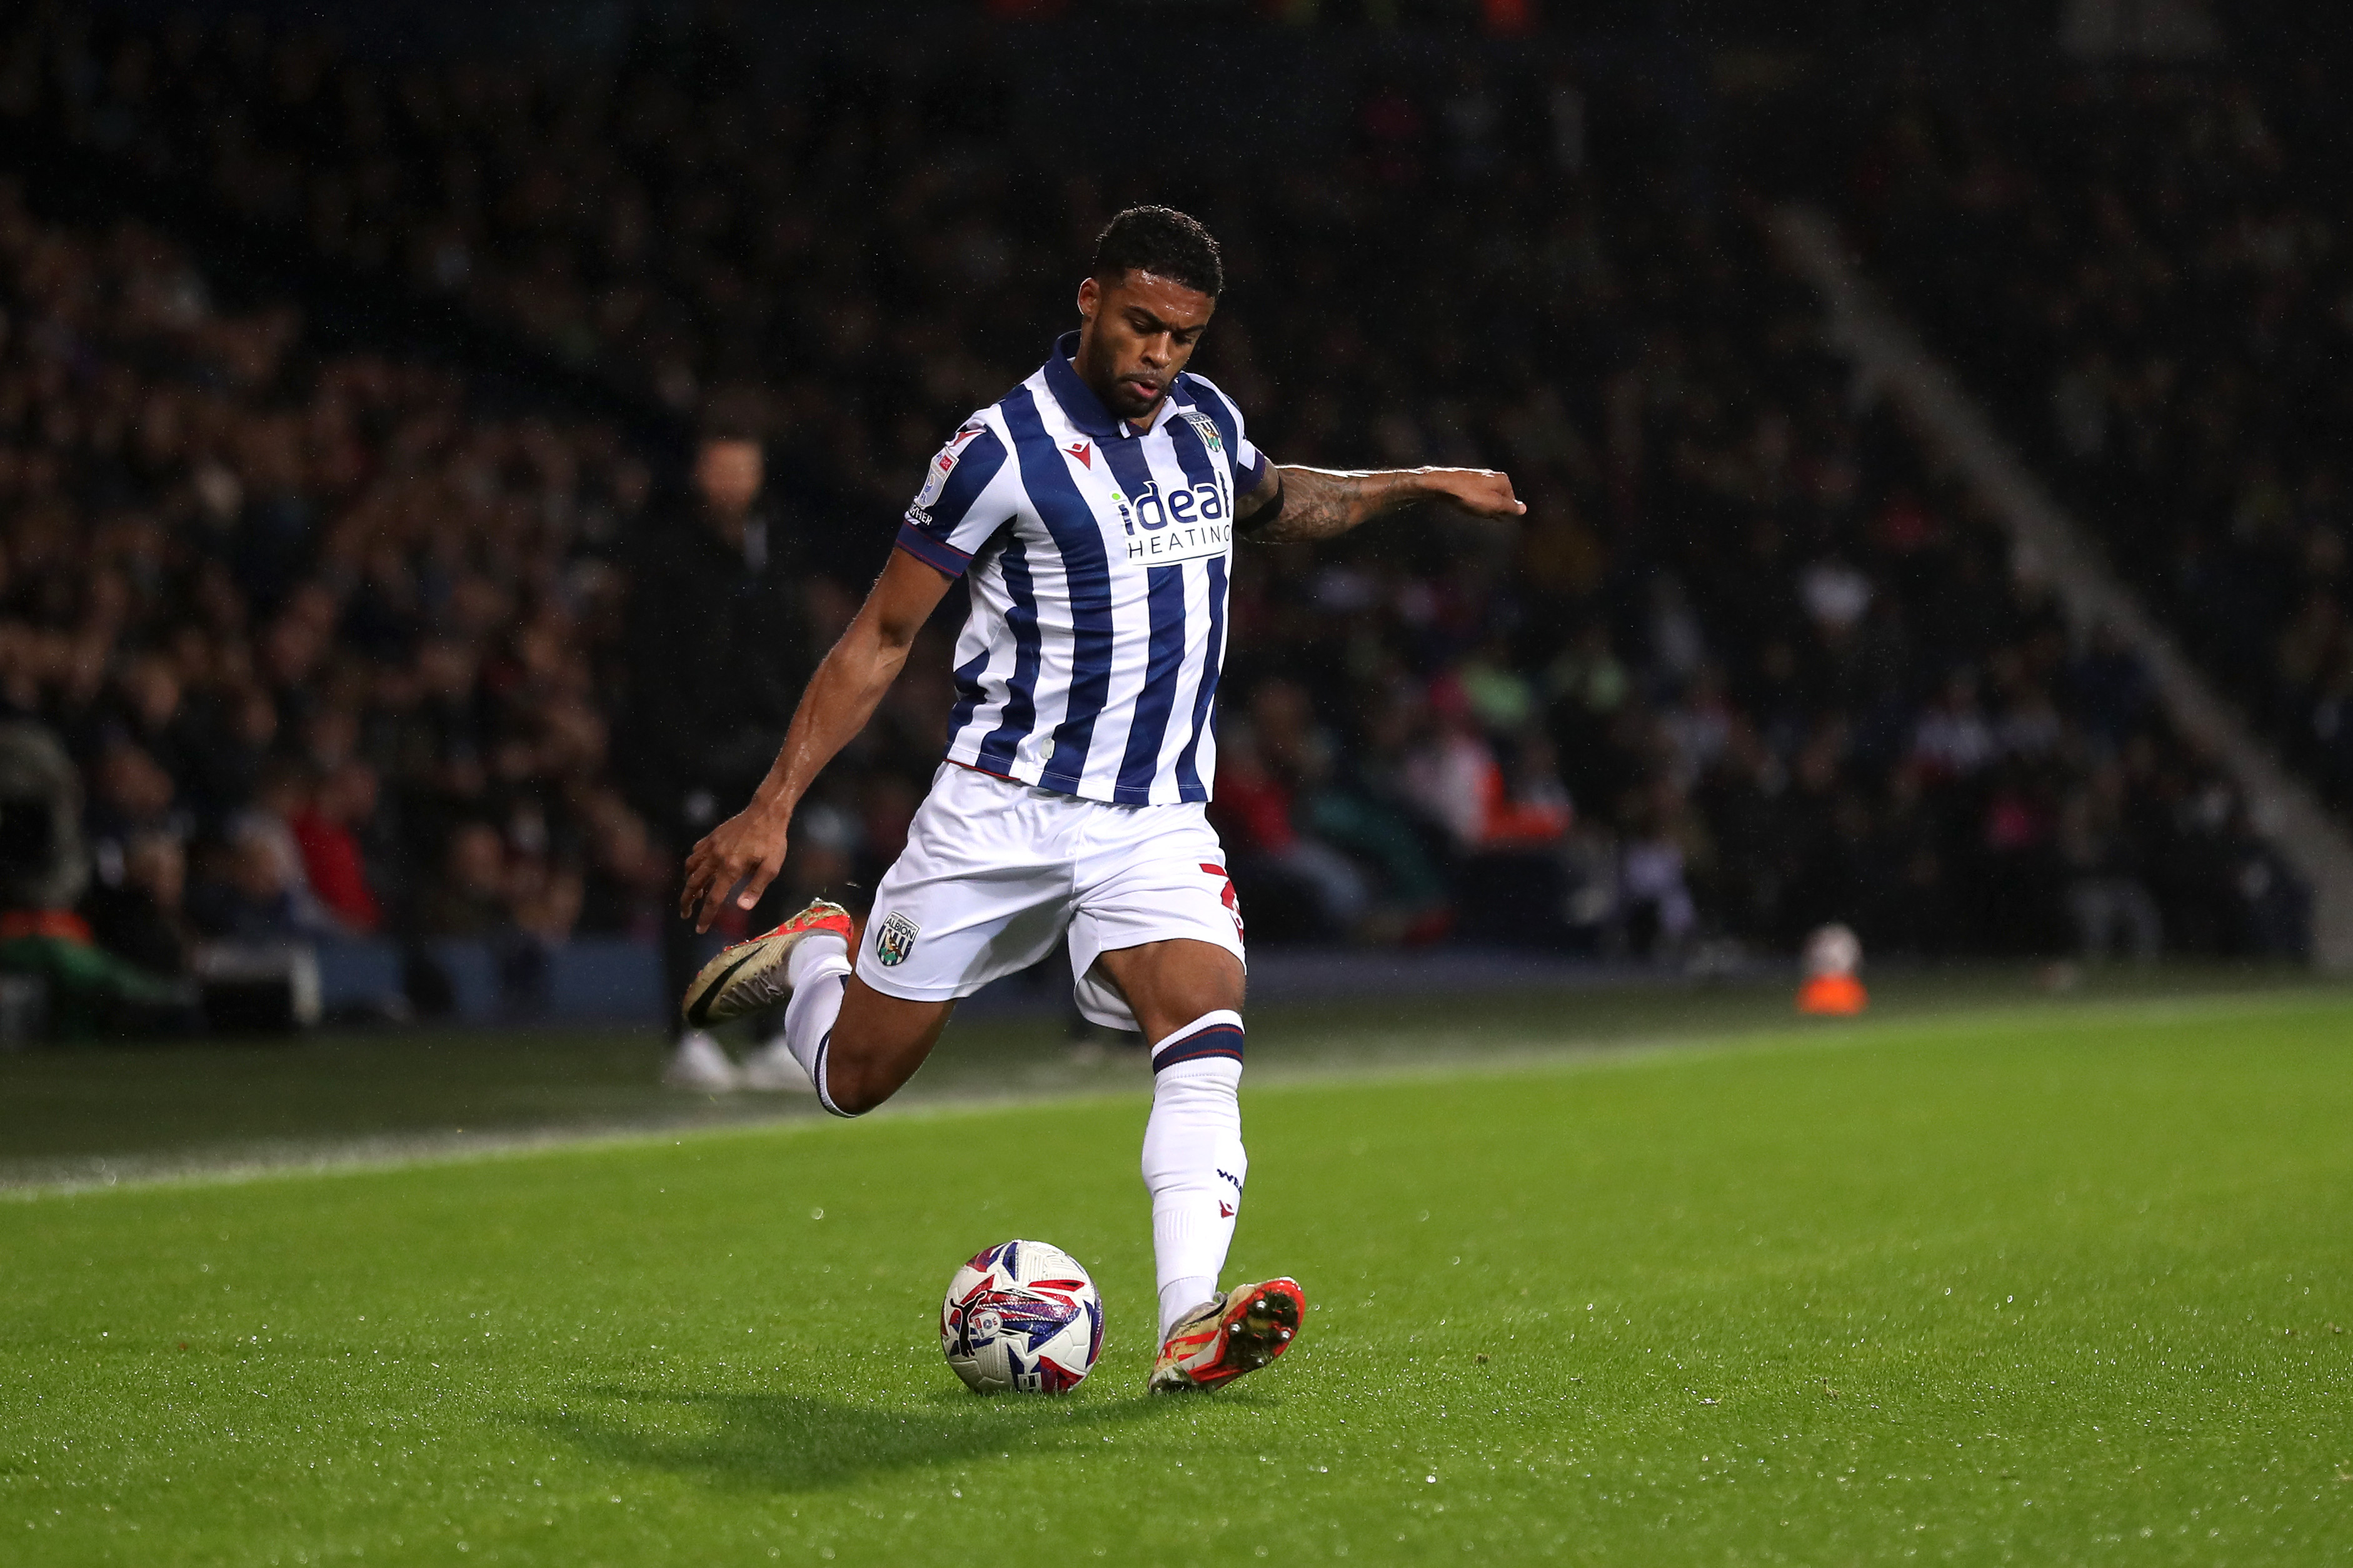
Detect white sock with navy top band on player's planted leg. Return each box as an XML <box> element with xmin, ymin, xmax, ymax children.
<box><xmin>1143</xmin><ymin>1009</ymin><xmax>1250</xmax><ymax>1340</ymax></box>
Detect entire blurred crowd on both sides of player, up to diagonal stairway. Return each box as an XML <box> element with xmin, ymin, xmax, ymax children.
<box><xmin>0</xmin><ymin>12</ymin><xmax>2304</xmax><ymax>982</ymax></box>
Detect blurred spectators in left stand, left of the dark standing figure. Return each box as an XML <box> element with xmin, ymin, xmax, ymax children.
<box><xmin>0</xmin><ymin>188</ymin><xmax>666</xmax><ymax>992</ymax></box>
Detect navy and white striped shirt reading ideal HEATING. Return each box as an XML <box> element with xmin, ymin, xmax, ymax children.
<box><xmin>899</xmin><ymin>331</ymin><xmax>1266</xmax><ymax>806</ymax></box>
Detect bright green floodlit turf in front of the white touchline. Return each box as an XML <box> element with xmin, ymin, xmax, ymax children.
<box><xmin>0</xmin><ymin>992</ymin><xmax>2353</xmax><ymax>1563</ymax></box>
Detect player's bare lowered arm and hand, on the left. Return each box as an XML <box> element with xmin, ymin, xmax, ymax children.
<box><xmin>678</xmin><ymin>550</ymin><xmax>948</xmax><ymax>931</ymax></box>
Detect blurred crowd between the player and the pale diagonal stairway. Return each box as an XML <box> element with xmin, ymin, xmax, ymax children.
<box><xmin>1219</xmin><ymin>187</ymin><xmax>2304</xmax><ymax>954</ymax></box>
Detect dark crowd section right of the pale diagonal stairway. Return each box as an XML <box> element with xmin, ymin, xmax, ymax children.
<box><xmin>1852</xmin><ymin>52</ymin><xmax>2353</xmax><ymax>809</ymax></box>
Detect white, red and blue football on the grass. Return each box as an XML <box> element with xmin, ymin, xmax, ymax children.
<box><xmin>939</xmin><ymin>1241</ymin><xmax>1103</xmax><ymax>1394</ymax></box>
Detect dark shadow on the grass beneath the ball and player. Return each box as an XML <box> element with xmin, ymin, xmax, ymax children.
<box><xmin>515</xmin><ymin>1385</ymin><xmax>1191</xmax><ymax>1491</ymax></box>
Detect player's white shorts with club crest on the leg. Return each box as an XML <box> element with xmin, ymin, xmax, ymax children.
<box><xmin>859</xmin><ymin>762</ymin><xmax>1242</xmax><ymax>1030</ymax></box>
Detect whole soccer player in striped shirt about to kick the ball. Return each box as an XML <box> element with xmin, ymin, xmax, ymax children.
<box><xmin>680</xmin><ymin>207</ymin><xmax>1527</xmax><ymax>1392</ymax></box>
